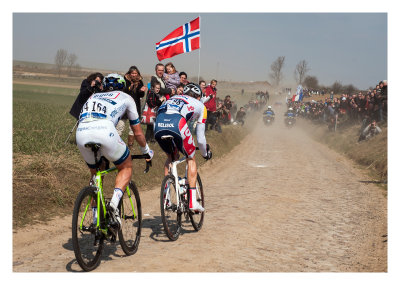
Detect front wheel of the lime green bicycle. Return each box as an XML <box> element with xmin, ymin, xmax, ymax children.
<box><xmin>118</xmin><ymin>182</ymin><xmax>142</xmax><ymax>255</ymax></box>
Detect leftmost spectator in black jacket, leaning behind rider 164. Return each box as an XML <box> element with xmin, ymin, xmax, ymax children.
<box><xmin>69</xmin><ymin>72</ymin><xmax>104</xmax><ymax>120</ymax></box>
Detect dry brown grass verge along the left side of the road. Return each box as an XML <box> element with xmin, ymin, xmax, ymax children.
<box><xmin>13</xmin><ymin>123</ymin><xmax>248</xmax><ymax>228</ymax></box>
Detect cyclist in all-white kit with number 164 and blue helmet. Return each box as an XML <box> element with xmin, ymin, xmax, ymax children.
<box><xmin>76</xmin><ymin>74</ymin><xmax>154</xmax><ymax>224</ymax></box>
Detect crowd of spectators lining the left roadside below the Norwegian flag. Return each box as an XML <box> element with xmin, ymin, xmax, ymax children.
<box><xmin>70</xmin><ymin>62</ymin><xmax>255</xmax><ymax>142</ymax></box>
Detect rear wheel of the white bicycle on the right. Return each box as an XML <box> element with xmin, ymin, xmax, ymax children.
<box><xmin>160</xmin><ymin>175</ymin><xmax>182</xmax><ymax>241</ymax></box>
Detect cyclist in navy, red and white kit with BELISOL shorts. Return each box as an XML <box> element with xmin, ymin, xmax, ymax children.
<box><xmin>154</xmin><ymin>83</ymin><xmax>212</xmax><ymax>212</ymax></box>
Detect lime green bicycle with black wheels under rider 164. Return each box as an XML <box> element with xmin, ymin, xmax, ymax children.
<box><xmin>72</xmin><ymin>143</ymin><xmax>151</xmax><ymax>271</ymax></box>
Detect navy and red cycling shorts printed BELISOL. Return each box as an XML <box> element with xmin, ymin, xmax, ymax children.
<box><xmin>154</xmin><ymin>113</ymin><xmax>196</xmax><ymax>158</ymax></box>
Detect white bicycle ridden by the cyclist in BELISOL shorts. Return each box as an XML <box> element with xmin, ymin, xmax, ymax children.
<box><xmin>160</xmin><ymin>135</ymin><xmax>204</xmax><ymax>241</ymax></box>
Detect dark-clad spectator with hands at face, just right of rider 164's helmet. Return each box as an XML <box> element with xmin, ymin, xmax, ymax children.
<box><xmin>115</xmin><ymin>65</ymin><xmax>147</xmax><ymax>148</ymax></box>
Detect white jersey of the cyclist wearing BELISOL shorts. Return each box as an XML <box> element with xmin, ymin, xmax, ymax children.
<box><xmin>158</xmin><ymin>95</ymin><xmax>207</xmax><ymax>124</ymax></box>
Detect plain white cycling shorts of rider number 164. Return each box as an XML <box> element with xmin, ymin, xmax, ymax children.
<box><xmin>76</xmin><ymin>119</ymin><xmax>130</xmax><ymax>169</ymax></box>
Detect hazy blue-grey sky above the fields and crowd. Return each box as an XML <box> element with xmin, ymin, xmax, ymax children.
<box><xmin>12</xmin><ymin>12</ymin><xmax>388</xmax><ymax>89</ymax></box>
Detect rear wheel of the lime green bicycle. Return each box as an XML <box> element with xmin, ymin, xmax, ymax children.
<box><xmin>72</xmin><ymin>187</ymin><xmax>104</xmax><ymax>271</ymax></box>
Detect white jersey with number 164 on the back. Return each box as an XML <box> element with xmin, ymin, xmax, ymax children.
<box><xmin>79</xmin><ymin>91</ymin><xmax>140</xmax><ymax>126</ymax></box>
